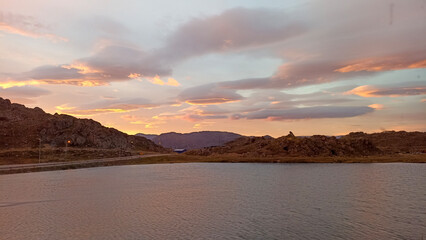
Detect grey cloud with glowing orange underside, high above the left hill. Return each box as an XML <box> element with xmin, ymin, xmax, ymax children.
<box><xmin>0</xmin><ymin>44</ymin><xmax>171</xmax><ymax>86</ymax></box>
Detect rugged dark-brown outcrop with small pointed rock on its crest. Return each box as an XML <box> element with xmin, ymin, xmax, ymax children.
<box><xmin>187</xmin><ymin>132</ymin><xmax>381</xmax><ymax>157</ymax></box>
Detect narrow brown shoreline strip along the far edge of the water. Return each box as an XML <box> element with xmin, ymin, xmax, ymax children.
<box><xmin>0</xmin><ymin>154</ymin><xmax>426</xmax><ymax>175</ymax></box>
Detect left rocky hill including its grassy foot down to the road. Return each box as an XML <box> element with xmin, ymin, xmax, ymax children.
<box><xmin>0</xmin><ymin>98</ymin><xmax>166</xmax><ymax>164</ymax></box>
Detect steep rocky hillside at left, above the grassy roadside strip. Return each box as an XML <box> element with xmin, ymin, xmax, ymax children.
<box><xmin>0</xmin><ymin>98</ymin><xmax>164</xmax><ymax>151</ymax></box>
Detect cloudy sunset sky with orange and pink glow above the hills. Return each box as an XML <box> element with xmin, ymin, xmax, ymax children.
<box><xmin>0</xmin><ymin>0</ymin><xmax>426</xmax><ymax>137</ymax></box>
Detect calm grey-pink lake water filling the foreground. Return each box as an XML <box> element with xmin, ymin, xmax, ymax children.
<box><xmin>0</xmin><ymin>163</ymin><xmax>426</xmax><ymax>240</ymax></box>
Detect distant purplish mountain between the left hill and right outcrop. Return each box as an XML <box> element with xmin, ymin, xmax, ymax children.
<box><xmin>136</xmin><ymin>131</ymin><xmax>242</xmax><ymax>149</ymax></box>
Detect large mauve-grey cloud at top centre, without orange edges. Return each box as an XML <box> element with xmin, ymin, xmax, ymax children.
<box><xmin>156</xmin><ymin>8</ymin><xmax>306</xmax><ymax>62</ymax></box>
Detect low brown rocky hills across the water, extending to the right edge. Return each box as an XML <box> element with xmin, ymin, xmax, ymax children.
<box><xmin>186</xmin><ymin>132</ymin><xmax>426</xmax><ymax>157</ymax></box>
